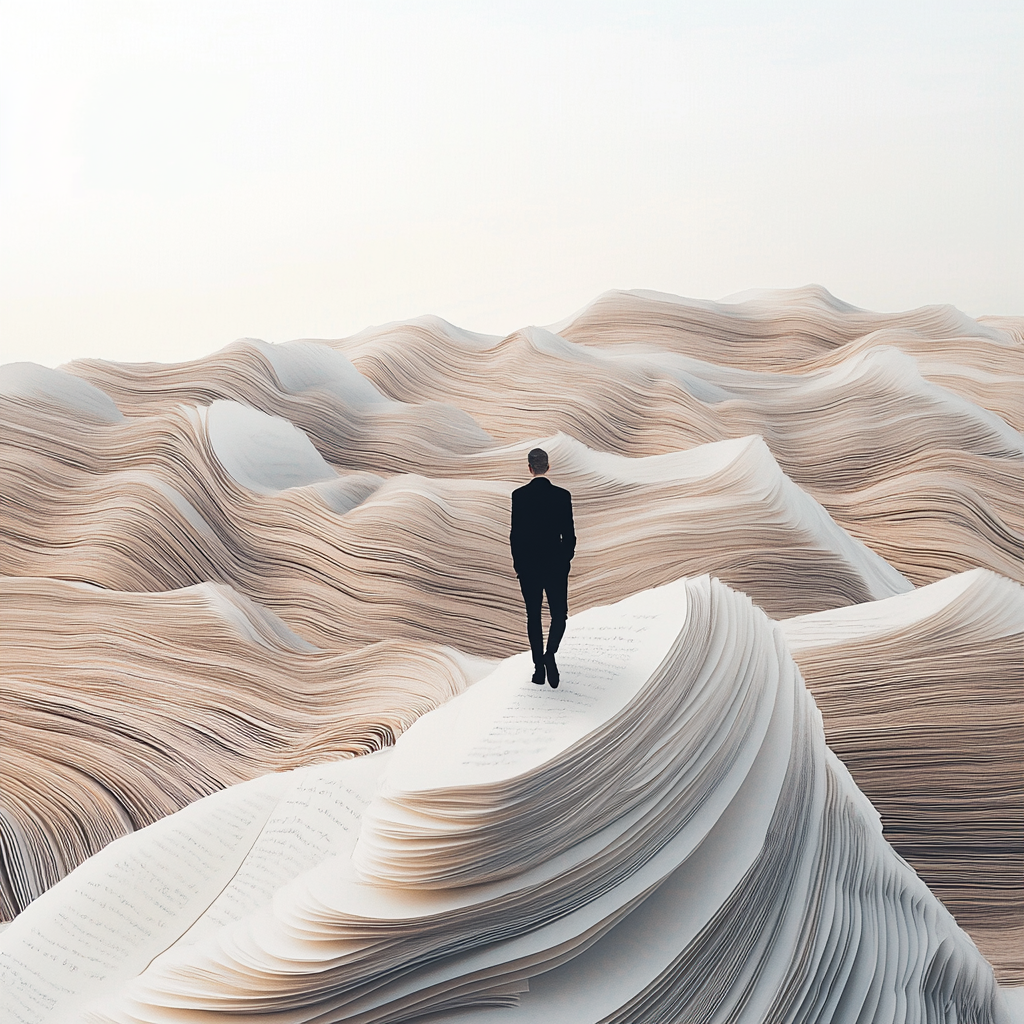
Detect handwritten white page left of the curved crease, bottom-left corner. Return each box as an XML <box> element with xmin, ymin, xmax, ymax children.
<box><xmin>0</xmin><ymin>775</ymin><xmax>289</xmax><ymax>1024</ymax></box>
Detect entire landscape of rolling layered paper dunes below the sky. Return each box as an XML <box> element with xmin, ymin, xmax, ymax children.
<box><xmin>0</xmin><ymin>289</ymin><xmax>1024</xmax><ymax>1024</ymax></box>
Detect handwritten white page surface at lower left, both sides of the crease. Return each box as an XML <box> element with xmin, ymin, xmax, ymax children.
<box><xmin>0</xmin><ymin>752</ymin><xmax>390</xmax><ymax>1024</ymax></box>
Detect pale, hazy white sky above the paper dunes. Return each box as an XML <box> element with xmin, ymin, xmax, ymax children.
<box><xmin>0</xmin><ymin>0</ymin><xmax>1024</xmax><ymax>366</ymax></box>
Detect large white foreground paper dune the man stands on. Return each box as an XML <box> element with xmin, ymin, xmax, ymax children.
<box><xmin>0</xmin><ymin>577</ymin><xmax>1010</xmax><ymax>1024</ymax></box>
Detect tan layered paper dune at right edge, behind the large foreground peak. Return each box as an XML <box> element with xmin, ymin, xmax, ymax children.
<box><xmin>780</xmin><ymin>569</ymin><xmax>1024</xmax><ymax>986</ymax></box>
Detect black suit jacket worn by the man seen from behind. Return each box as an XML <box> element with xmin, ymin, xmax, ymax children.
<box><xmin>509</xmin><ymin>476</ymin><xmax>575</xmax><ymax>579</ymax></box>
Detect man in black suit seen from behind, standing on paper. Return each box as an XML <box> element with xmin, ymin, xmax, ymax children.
<box><xmin>509</xmin><ymin>449</ymin><xmax>575</xmax><ymax>689</ymax></box>
